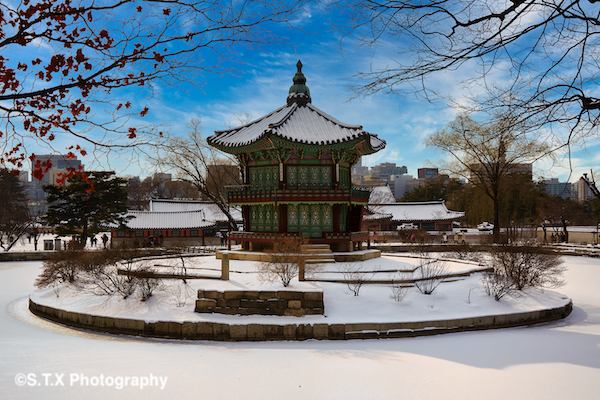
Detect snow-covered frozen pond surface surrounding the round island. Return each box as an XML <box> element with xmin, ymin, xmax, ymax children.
<box><xmin>0</xmin><ymin>252</ymin><xmax>600</xmax><ymax>399</ymax></box>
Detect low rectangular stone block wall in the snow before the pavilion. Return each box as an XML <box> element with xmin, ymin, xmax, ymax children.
<box><xmin>194</xmin><ymin>290</ymin><xmax>325</xmax><ymax>317</ymax></box>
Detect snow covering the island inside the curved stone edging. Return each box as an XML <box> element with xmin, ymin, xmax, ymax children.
<box><xmin>31</xmin><ymin>254</ymin><xmax>569</xmax><ymax>324</ymax></box>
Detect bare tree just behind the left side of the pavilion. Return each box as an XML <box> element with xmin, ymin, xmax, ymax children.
<box><xmin>154</xmin><ymin>118</ymin><xmax>241</xmax><ymax>230</ymax></box>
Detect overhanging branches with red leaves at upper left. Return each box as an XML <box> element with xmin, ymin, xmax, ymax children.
<box><xmin>0</xmin><ymin>0</ymin><xmax>304</xmax><ymax>173</ymax></box>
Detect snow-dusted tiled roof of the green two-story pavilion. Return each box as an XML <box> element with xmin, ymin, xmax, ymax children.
<box><xmin>207</xmin><ymin>103</ymin><xmax>385</xmax><ymax>151</ymax></box>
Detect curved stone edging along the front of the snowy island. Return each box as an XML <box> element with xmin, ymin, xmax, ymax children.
<box><xmin>29</xmin><ymin>299</ymin><xmax>573</xmax><ymax>341</ymax></box>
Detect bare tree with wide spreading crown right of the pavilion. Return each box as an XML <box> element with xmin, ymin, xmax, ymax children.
<box><xmin>427</xmin><ymin>115</ymin><xmax>551</xmax><ymax>242</ymax></box>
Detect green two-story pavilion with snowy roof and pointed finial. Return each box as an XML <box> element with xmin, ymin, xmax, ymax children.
<box><xmin>208</xmin><ymin>62</ymin><xmax>385</xmax><ymax>250</ymax></box>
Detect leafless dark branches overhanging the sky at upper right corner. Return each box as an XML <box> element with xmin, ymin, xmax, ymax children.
<box><xmin>335</xmin><ymin>0</ymin><xmax>600</xmax><ymax>150</ymax></box>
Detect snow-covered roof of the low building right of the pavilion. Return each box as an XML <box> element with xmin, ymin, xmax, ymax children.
<box><xmin>369</xmin><ymin>201</ymin><xmax>465</xmax><ymax>222</ymax></box>
